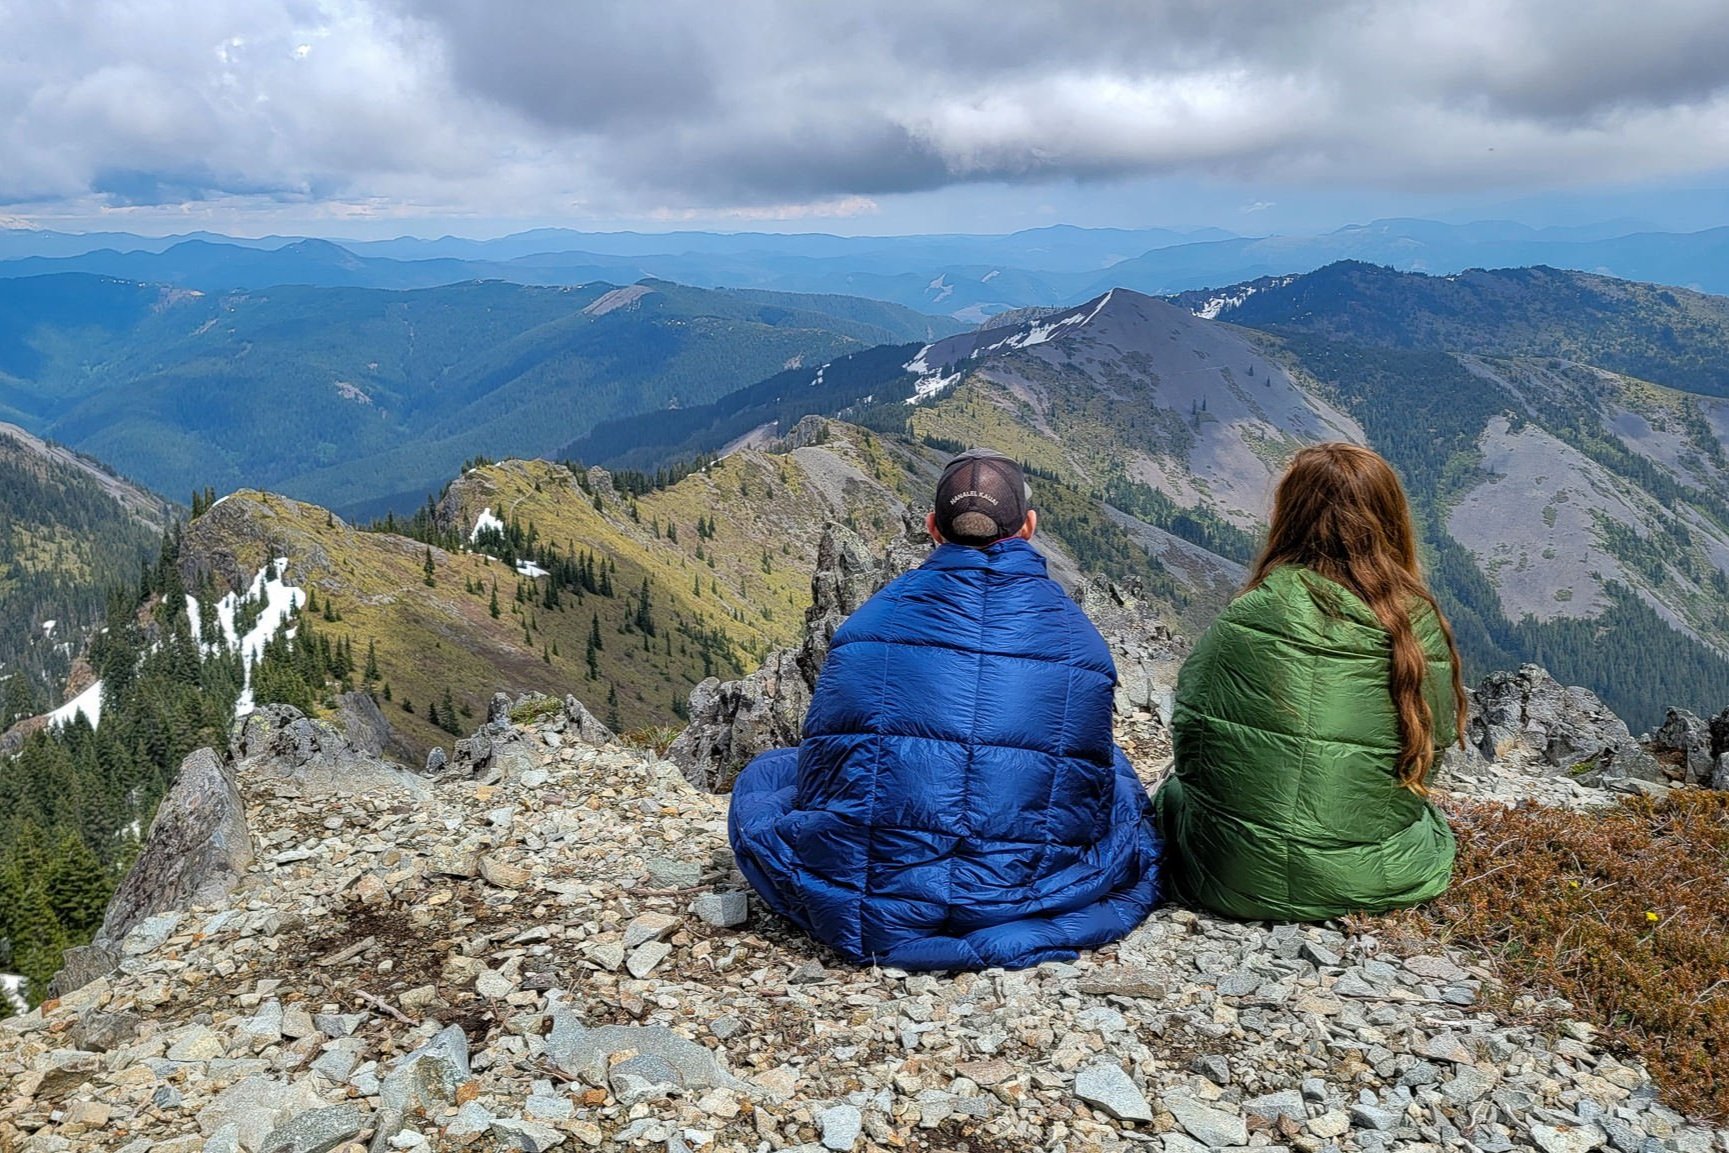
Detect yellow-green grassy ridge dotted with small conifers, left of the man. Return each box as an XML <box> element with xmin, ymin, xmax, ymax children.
<box><xmin>170</xmin><ymin>427</ymin><xmax>926</xmax><ymax>759</ymax></box>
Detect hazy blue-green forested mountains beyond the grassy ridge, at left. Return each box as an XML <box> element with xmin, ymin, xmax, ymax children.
<box><xmin>0</xmin><ymin>275</ymin><xmax>954</xmax><ymax>512</ymax></box>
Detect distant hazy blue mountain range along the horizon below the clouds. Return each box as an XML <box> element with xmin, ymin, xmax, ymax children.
<box><xmin>0</xmin><ymin>220</ymin><xmax>1729</xmax><ymax>312</ymax></box>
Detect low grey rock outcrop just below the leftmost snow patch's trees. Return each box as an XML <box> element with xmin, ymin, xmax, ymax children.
<box><xmin>228</xmin><ymin>702</ymin><xmax>432</xmax><ymax>800</ymax></box>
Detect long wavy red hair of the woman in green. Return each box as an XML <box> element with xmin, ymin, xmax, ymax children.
<box><xmin>1243</xmin><ymin>443</ymin><xmax>1464</xmax><ymax>795</ymax></box>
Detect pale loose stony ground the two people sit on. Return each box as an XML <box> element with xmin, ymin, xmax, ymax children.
<box><xmin>0</xmin><ymin>681</ymin><xmax>1729</xmax><ymax>1153</ymax></box>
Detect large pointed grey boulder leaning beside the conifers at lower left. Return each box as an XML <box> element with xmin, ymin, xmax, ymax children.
<box><xmin>84</xmin><ymin>748</ymin><xmax>252</xmax><ymax>961</ymax></box>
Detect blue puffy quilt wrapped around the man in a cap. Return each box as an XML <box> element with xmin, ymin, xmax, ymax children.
<box><xmin>728</xmin><ymin>539</ymin><xmax>1158</xmax><ymax>970</ymax></box>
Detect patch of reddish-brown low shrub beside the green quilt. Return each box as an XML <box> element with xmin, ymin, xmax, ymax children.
<box><xmin>1397</xmin><ymin>790</ymin><xmax>1729</xmax><ymax>1122</ymax></box>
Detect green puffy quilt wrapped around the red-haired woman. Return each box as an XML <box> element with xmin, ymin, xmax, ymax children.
<box><xmin>1155</xmin><ymin>565</ymin><xmax>1456</xmax><ymax>921</ymax></box>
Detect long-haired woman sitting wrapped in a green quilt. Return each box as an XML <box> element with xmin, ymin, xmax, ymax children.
<box><xmin>1155</xmin><ymin>444</ymin><xmax>1464</xmax><ymax>921</ymax></box>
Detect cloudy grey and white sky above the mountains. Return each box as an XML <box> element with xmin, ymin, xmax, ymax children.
<box><xmin>10</xmin><ymin>0</ymin><xmax>1729</xmax><ymax>235</ymax></box>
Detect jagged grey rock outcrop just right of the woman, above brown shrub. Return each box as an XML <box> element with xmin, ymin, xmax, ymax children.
<box><xmin>1466</xmin><ymin>664</ymin><xmax>1668</xmax><ymax>788</ymax></box>
